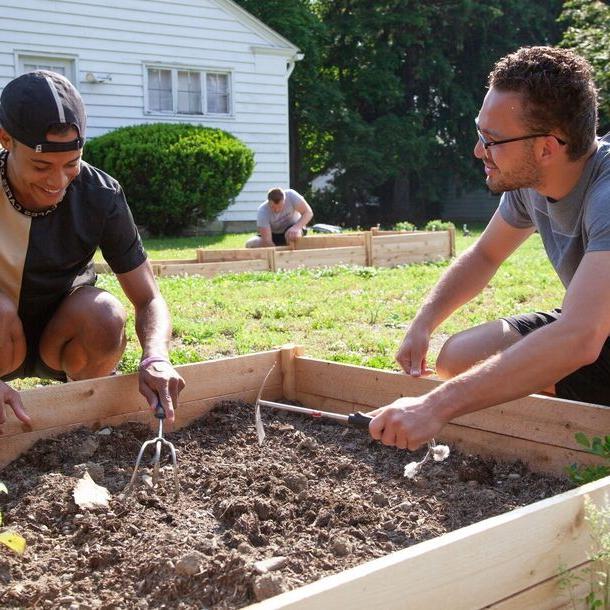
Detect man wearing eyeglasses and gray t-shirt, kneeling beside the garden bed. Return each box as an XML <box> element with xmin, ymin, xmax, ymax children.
<box><xmin>370</xmin><ymin>47</ymin><xmax>610</xmax><ymax>449</ymax></box>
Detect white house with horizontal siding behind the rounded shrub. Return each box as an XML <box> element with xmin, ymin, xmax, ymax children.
<box><xmin>0</xmin><ymin>0</ymin><xmax>302</xmax><ymax>228</ymax></box>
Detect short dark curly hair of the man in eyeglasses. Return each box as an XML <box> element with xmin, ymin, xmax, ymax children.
<box><xmin>488</xmin><ymin>47</ymin><xmax>598</xmax><ymax>161</ymax></box>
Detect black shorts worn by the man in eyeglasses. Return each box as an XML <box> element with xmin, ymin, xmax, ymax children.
<box><xmin>502</xmin><ymin>308</ymin><xmax>610</xmax><ymax>406</ymax></box>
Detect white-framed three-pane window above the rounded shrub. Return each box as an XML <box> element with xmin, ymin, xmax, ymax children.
<box><xmin>146</xmin><ymin>68</ymin><xmax>231</xmax><ymax>115</ymax></box>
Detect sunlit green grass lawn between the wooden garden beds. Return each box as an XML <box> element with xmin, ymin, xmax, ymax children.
<box><xmin>91</xmin><ymin>231</ymin><xmax>564</xmax><ymax>372</ymax></box>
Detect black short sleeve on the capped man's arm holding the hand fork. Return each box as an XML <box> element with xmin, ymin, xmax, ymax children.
<box><xmin>100</xmin><ymin>186</ymin><xmax>147</xmax><ymax>273</ymax></box>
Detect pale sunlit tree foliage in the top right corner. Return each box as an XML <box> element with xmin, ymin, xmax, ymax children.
<box><xmin>559</xmin><ymin>0</ymin><xmax>610</xmax><ymax>133</ymax></box>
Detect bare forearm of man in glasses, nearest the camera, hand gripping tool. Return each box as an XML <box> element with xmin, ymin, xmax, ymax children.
<box><xmin>425</xmin><ymin>321</ymin><xmax>590</xmax><ymax>421</ymax></box>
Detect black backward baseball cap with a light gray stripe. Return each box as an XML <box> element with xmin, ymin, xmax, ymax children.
<box><xmin>0</xmin><ymin>70</ymin><xmax>87</xmax><ymax>152</ymax></box>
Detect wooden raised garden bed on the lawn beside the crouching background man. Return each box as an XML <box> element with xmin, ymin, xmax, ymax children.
<box><xmin>95</xmin><ymin>230</ymin><xmax>455</xmax><ymax>277</ymax></box>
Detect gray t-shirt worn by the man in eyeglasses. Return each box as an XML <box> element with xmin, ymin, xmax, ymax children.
<box><xmin>499</xmin><ymin>134</ymin><xmax>610</xmax><ymax>288</ymax></box>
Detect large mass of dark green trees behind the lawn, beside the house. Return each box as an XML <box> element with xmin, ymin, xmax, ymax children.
<box><xmin>240</xmin><ymin>0</ymin><xmax>561</xmax><ymax>224</ymax></box>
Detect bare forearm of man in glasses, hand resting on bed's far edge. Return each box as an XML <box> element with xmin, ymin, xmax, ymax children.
<box><xmin>412</xmin><ymin>246</ymin><xmax>498</xmax><ymax>333</ymax></box>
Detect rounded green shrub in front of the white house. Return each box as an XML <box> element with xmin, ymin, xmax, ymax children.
<box><xmin>85</xmin><ymin>123</ymin><xmax>254</xmax><ymax>235</ymax></box>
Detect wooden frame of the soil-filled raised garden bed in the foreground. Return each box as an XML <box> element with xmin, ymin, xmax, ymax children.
<box><xmin>0</xmin><ymin>346</ymin><xmax>610</xmax><ymax>610</ymax></box>
